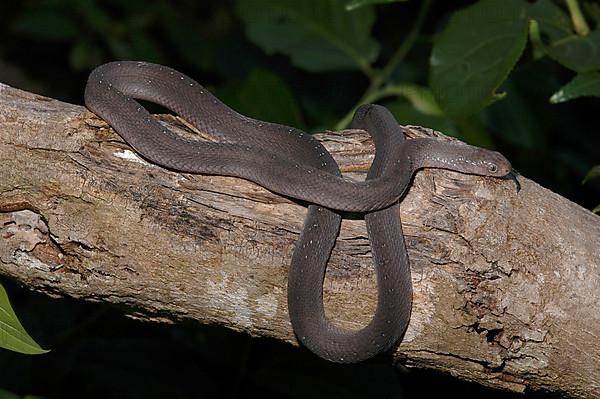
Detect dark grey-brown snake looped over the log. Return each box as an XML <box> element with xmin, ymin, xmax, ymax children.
<box><xmin>84</xmin><ymin>61</ymin><xmax>520</xmax><ymax>363</ymax></box>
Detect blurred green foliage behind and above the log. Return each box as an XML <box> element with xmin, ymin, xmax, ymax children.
<box><xmin>4</xmin><ymin>0</ymin><xmax>600</xmax><ymax>152</ymax></box>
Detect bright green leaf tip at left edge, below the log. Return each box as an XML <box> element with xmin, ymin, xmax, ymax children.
<box><xmin>0</xmin><ymin>284</ymin><xmax>48</xmax><ymax>355</ymax></box>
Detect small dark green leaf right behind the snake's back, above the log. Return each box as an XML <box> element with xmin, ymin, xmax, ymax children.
<box><xmin>219</xmin><ymin>69</ymin><xmax>304</xmax><ymax>129</ymax></box>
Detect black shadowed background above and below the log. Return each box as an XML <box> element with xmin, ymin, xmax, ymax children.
<box><xmin>0</xmin><ymin>0</ymin><xmax>600</xmax><ymax>398</ymax></box>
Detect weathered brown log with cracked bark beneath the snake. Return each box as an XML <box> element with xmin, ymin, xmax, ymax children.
<box><xmin>0</xmin><ymin>84</ymin><xmax>600</xmax><ymax>398</ymax></box>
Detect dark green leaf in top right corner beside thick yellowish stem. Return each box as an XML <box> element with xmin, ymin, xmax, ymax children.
<box><xmin>529</xmin><ymin>0</ymin><xmax>600</xmax><ymax>73</ymax></box>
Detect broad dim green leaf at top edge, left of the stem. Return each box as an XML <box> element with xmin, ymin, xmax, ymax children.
<box><xmin>238</xmin><ymin>0</ymin><xmax>379</xmax><ymax>72</ymax></box>
